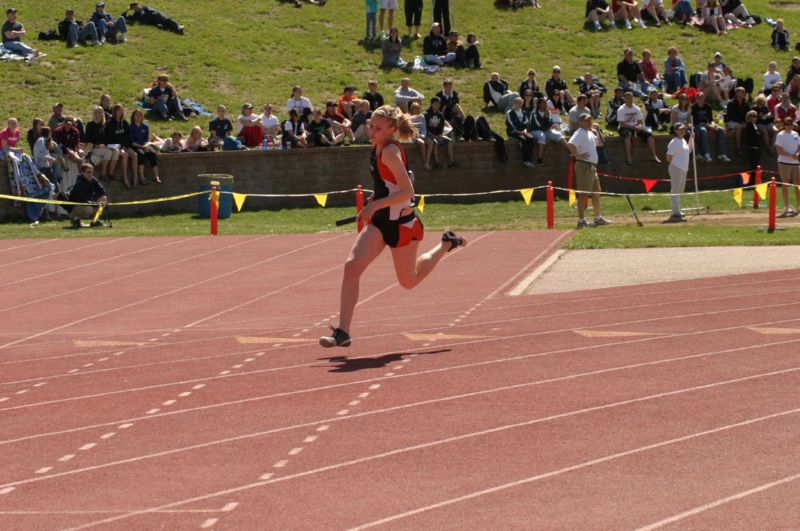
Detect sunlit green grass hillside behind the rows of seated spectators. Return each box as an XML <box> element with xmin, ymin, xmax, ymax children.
<box><xmin>0</xmin><ymin>0</ymin><xmax>800</xmax><ymax>135</ymax></box>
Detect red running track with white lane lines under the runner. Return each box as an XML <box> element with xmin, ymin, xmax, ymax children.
<box><xmin>0</xmin><ymin>232</ymin><xmax>800</xmax><ymax>530</ymax></box>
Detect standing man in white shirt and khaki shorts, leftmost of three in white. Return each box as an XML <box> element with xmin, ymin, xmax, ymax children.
<box><xmin>567</xmin><ymin>113</ymin><xmax>611</xmax><ymax>229</ymax></box>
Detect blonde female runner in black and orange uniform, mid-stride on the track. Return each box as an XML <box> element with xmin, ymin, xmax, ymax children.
<box><xmin>319</xmin><ymin>105</ymin><xmax>467</xmax><ymax>347</ymax></box>
